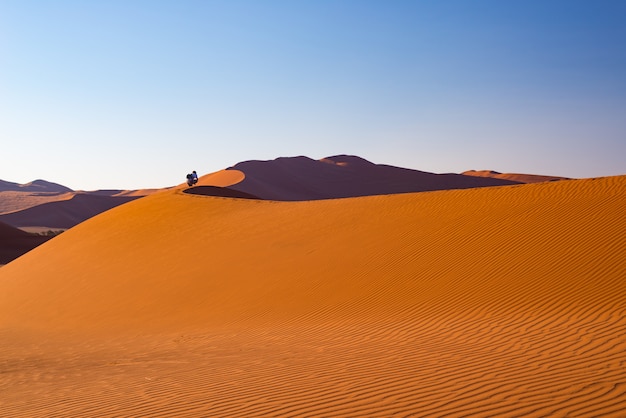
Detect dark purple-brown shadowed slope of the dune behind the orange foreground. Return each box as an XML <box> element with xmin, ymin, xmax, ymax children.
<box><xmin>227</xmin><ymin>155</ymin><xmax>517</xmax><ymax>201</ymax></box>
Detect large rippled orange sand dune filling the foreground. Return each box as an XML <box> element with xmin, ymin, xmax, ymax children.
<box><xmin>0</xmin><ymin>176</ymin><xmax>626</xmax><ymax>417</ymax></box>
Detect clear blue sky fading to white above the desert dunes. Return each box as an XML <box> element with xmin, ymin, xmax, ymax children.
<box><xmin>0</xmin><ymin>0</ymin><xmax>626</xmax><ymax>190</ymax></box>
